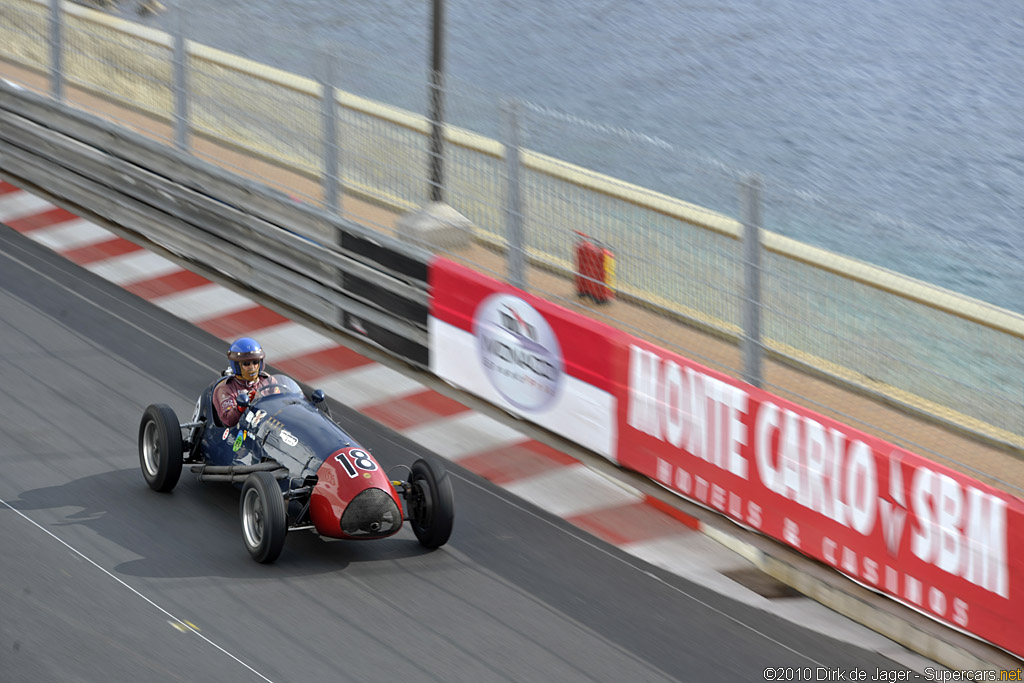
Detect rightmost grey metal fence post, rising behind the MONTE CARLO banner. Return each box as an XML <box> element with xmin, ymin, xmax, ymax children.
<box><xmin>739</xmin><ymin>176</ymin><xmax>764</xmax><ymax>388</ymax></box>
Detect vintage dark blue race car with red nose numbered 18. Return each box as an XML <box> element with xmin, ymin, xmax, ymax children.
<box><xmin>138</xmin><ymin>375</ymin><xmax>455</xmax><ymax>562</ymax></box>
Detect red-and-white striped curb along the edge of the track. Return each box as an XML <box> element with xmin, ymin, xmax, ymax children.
<box><xmin>0</xmin><ymin>181</ymin><xmax>909</xmax><ymax>643</ymax></box>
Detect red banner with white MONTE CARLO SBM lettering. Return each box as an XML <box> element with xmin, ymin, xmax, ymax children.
<box><xmin>617</xmin><ymin>339</ymin><xmax>1024</xmax><ymax>655</ymax></box>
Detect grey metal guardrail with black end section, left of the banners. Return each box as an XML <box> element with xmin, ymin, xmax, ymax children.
<box><xmin>0</xmin><ymin>82</ymin><xmax>429</xmax><ymax>368</ymax></box>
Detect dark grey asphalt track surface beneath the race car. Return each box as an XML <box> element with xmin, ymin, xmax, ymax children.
<box><xmin>0</xmin><ymin>226</ymin><xmax>902</xmax><ymax>682</ymax></box>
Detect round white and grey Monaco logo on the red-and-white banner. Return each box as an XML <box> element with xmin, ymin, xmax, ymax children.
<box><xmin>473</xmin><ymin>294</ymin><xmax>564</xmax><ymax>411</ymax></box>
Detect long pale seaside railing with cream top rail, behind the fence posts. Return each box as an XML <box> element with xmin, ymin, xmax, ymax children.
<box><xmin>0</xmin><ymin>0</ymin><xmax>1024</xmax><ymax>449</ymax></box>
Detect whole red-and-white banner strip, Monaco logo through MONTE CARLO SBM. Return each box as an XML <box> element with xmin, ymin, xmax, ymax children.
<box><xmin>429</xmin><ymin>258</ymin><xmax>1024</xmax><ymax>656</ymax></box>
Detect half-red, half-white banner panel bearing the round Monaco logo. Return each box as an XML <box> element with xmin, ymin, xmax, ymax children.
<box><xmin>428</xmin><ymin>258</ymin><xmax>623</xmax><ymax>458</ymax></box>
